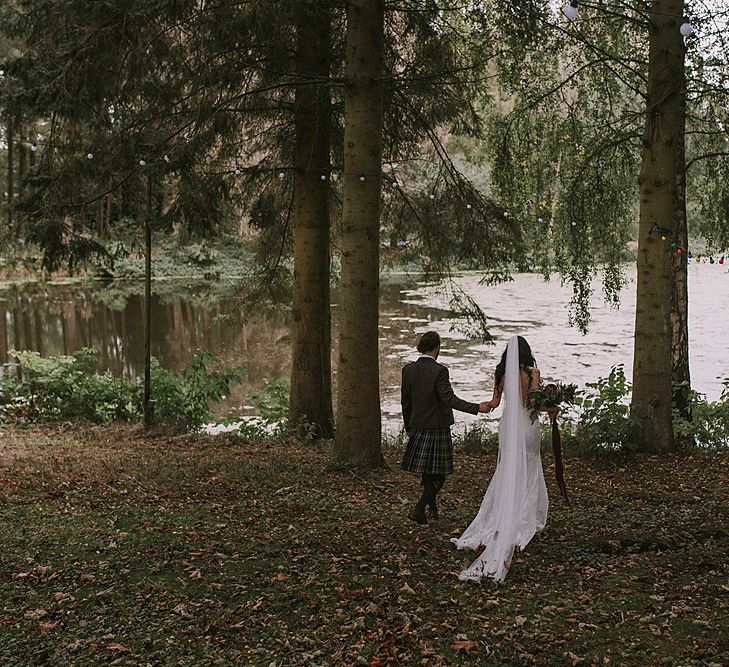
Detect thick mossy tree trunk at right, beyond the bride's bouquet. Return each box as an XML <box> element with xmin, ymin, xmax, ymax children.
<box><xmin>630</xmin><ymin>0</ymin><xmax>686</xmax><ymax>452</ymax></box>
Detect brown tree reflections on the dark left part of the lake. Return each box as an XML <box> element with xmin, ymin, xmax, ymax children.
<box><xmin>0</xmin><ymin>284</ymin><xmax>291</xmax><ymax>416</ymax></box>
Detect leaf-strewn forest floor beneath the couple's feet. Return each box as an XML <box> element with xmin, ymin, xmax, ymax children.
<box><xmin>0</xmin><ymin>425</ymin><xmax>729</xmax><ymax>667</ymax></box>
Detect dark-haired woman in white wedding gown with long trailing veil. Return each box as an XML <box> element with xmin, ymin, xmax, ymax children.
<box><xmin>451</xmin><ymin>336</ymin><xmax>559</xmax><ymax>582</ymax></box>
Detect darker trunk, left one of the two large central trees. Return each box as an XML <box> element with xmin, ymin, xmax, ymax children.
<box><xmin>289</xmin><ymin>2</ymin><xmax>334</xmax><ymax>438</ymax></box>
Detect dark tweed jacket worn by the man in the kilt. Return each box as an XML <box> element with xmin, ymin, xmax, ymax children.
<box><xmin>401</xmin><ymin>357</ymin><xmax>478</xmax><ymax>433</ymax></box>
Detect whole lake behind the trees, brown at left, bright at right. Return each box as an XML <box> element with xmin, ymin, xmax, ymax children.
<box><xmin>0</xmin><ymin>262</ymin><xmax>729</xmax><ymax>431</ymax></box>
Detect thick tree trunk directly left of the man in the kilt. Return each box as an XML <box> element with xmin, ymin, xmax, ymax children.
<box><xmin>334</xmin><ymin>0</ymin><xmax>384</xmax><ymax>467</ymax></box>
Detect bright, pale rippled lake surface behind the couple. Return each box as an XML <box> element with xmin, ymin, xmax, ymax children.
<box><xmin>382</xmin><ymin>263</ymin><xmax>729</xmax><ymax>434</ymax></box>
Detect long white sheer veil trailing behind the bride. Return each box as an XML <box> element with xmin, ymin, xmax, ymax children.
<box><xmin>451</xmin><ymin>336</ymin><xmax>537</xmax><ymax>581</ymax></box>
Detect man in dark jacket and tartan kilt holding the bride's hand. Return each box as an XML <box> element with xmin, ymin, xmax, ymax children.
<box><xmin>401</xmin><ymin>331</ymin><xmax>491</xmax><ymax>524</ymax></box>
